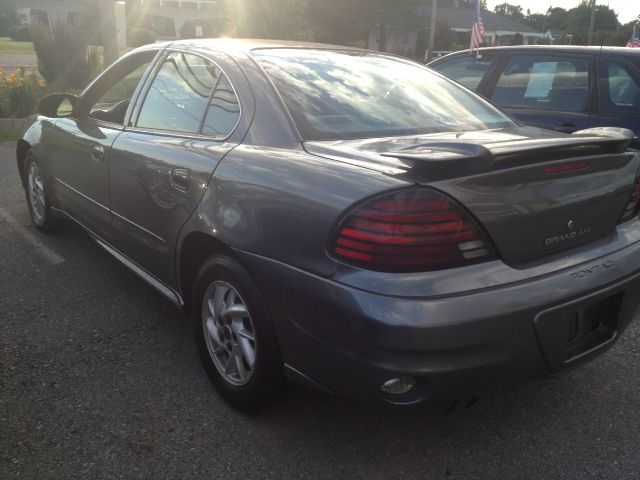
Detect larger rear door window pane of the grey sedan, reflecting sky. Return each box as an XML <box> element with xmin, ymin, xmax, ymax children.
<box><xmin>137</xmin><ymin>53</ymin><xmax>220</xmax><ymax>133</ymax></box>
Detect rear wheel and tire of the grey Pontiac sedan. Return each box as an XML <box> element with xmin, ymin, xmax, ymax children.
<box><xmin>192</xmin><ymin>255</ymin><xmax>285</xmax><ymax>411</ymax></box>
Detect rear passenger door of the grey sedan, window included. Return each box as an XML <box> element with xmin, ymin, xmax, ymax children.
<box><xmin>109</xmin><ymin>51</ymin><xmax>241</xmax><ymax>285</ymax></box>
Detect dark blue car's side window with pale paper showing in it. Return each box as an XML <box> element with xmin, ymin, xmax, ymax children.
<box><xmin>491</xmin><ymin>55</ymin><xmax>589</xmax><ymax>112</ymax></box>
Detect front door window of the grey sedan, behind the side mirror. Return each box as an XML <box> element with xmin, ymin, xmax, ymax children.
<box><xmin>89</xmin><ymin>52</ymin><xmax>156</xmax><ymax>125</ymax></box>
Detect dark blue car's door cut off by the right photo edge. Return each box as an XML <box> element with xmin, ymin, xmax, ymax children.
<box><xmin>596</xmin><ymin>57</ymin><xmax>640</xmax><ymax>147</ymax></box>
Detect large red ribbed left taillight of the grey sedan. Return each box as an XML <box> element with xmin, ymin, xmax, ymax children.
<box><xmin>330</xmin><ymin>188</ymin><xmax>495</xmax><ymax>272</ymax></box>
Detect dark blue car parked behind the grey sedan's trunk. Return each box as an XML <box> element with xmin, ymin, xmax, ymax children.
<box><xmin>429</xmin><ymin>46</ymin><xmax>640</xmax><ymax>147</ymax></box>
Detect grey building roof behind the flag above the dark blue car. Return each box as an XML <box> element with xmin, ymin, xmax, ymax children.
<box><xmin>419</xmin><ymin>6</ymin><xmax>543</xmax><ymax>35</ymax></box>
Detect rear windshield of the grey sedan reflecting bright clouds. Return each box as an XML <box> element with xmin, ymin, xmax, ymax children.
<box><xmin>253</xmin><ymin>49</ymin><xmax>514</xmax><ymax>140</ymax></box>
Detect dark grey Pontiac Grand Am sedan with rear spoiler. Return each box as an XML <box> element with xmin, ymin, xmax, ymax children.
<box><xmin>17</xmin><ymin>39</ymin><xmax>640</xmax><ymax>408</ymax></box>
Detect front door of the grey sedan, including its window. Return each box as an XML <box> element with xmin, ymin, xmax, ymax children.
<box><xmin>48</xmin><ymin>51</ymin><xmax>157</xmax><ymax>239</ymax></box>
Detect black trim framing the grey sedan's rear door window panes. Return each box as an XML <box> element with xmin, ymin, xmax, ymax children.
<box><xmin>124</xmin><ymin>47</ymin><xmax>244</xmax><ymax>142</ymax></box>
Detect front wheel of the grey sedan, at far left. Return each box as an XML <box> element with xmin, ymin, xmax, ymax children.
<box><xmin>24</xmin><ymin>153</ymin><xmax>59</xmax><ymax>233</ymax></box>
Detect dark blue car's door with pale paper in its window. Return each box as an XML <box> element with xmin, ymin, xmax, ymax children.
<box><xmin>487</xmin><ymin>53</ymin><xmax>596</xmax><ymax>133</ymax></box>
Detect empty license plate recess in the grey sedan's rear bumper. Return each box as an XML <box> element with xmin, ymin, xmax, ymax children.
<box><xmin>535</xmin><ymin>292</ymin><xmax>625</xmax><ymax>373</ymax></box>
